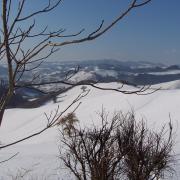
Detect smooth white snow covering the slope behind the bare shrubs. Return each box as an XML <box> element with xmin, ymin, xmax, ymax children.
<box><xmin>0</xmin><ymin>81</ymin><xmax>180</xmax><ymax>180</ymax></box>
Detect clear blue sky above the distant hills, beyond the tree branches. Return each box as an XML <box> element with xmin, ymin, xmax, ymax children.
<box><xmin>23</xmin><ymin>0</ymin><xmax>180</xmax><ymax>64</ymax></box>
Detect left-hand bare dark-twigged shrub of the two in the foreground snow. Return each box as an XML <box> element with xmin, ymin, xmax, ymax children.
<box><xmin>60</xmin><ymin>110</ymin><xmax>122</xmax><ymax>180</ymax></box>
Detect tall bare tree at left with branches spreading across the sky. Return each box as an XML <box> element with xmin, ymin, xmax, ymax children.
<box><xmin>0</xmin><ymin>0</ymin><xmax>151</xmax><ymax>125</ymax></box>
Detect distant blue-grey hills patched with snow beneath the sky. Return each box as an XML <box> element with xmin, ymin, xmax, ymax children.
<box><xmin>0</xmin><ymin>59</ymin><xmax>180</xmax><ymax>106</ymax></box>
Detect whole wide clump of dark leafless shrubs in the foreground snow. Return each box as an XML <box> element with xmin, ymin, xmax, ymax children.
<box><xmin>59</xmin><ymin>111</ymin><xmax>174</xmax><ymax>180</ymax></box>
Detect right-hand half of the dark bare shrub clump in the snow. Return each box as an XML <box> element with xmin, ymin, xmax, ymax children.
<box><xmin>117</xmin><ymin>113</ymin><xmax>174</xmax><ymax>180</ymax></box>
